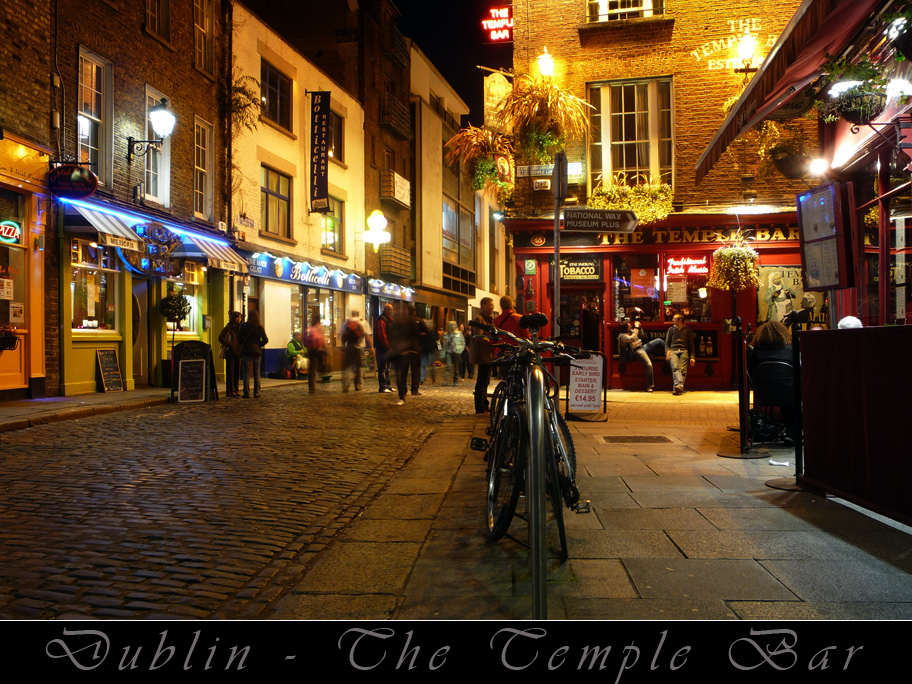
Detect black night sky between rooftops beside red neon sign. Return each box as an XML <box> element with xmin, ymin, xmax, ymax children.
<box><xmin>394</xmin><ymin>0</ymin><xmax>513</xmax><ymax>126</ymax></box>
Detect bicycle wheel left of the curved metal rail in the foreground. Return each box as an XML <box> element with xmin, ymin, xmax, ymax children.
<box><xmin>485</xmin><ymin>407</ymin><xmax>528</xmax><ymax>541</ymax></box>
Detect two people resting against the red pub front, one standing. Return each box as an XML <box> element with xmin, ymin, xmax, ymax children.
<box><xmin>618</xmin><ymin>314</ymin><xmax>697</xmax><ymax>395</ymax></box>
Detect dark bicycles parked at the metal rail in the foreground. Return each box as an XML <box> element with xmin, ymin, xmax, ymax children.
<box><xmin>472</xmin><ymin>314</ymin><xmax>589</xmax><ymax>560</ymax></box>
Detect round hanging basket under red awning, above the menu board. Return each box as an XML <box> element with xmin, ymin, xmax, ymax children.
<box><xmin>817</xmin><ymin>55</ymin><xmax>887</xmax><ymax>125</ymax></box>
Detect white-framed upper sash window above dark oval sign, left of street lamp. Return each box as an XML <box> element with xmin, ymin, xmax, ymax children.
<box><xmin>76</xmin><ymin>51</ymin><xmax>111</xmax><ymax>185</ymax></box>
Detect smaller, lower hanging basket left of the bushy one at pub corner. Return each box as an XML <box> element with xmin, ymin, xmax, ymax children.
<box><xmin>445</xmin><ymin>125</ymin><xmax>513</xmax><ymax>207</ymax></box>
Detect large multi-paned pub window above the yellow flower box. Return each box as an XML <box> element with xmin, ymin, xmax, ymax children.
<box><xmin>589</xmin><ymin>78</ymin><xmax>674</xmax><ymax>188</ymax></box>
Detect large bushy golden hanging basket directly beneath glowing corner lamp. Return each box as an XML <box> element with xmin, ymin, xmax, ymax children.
<box><xmin>496</xmin><ymin>75</ymin><xmax>590</xmax><ymax>164</ymax></box>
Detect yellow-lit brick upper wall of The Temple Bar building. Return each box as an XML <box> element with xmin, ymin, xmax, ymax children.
<box><xmin>513</xmin><ymin>0</ymin><xmax>817</xmax><ymax>213</ymax></box>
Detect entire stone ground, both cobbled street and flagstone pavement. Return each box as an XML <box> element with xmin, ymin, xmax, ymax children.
<box><xmin>0</xmin><ymin>380</ymin><xmax>912</xmax><ymax>620</ymax></box>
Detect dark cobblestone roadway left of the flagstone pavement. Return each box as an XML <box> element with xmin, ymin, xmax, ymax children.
<box><xmin>0</xmin><ymin>380</ymin><xmax>472</xmax><ymax>619</ymax></box>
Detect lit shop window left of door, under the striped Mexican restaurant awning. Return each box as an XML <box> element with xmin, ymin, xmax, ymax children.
<box><xmin>70</xmin><ymin>239</ymin><xmax>119</xmax><ymax>330</ymax></box>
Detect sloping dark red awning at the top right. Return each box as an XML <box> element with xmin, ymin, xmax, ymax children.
<box><xmin>694</xmin><ymin>0</ymin><xmax>884</xmax><ymax>184</ymax></box>
